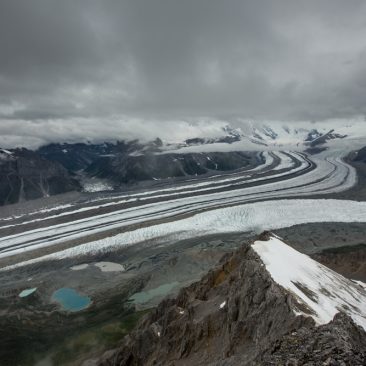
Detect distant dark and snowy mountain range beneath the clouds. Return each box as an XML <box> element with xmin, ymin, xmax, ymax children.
<box><xmin>0</xmin><ymin>123</ymin><xmax>366</xmax><ymax>205</ymax></box>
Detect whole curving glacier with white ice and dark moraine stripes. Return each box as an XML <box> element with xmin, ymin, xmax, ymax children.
<box><xmin>0</xmin><ymin>147</ymin><xmax>366</xmax><ymax>270</ymax></box>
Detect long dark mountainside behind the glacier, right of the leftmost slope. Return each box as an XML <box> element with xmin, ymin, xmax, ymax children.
<box><xmin>38</xmin><ymin>142</ymin><xmax>258</xmax><ymax>184</ymax></box>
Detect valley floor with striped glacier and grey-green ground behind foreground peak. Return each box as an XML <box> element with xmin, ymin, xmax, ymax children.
<box><xmin>0</xmin><ymin>147</ymin><xmax>366</xmax><ymax>366</ymax></box>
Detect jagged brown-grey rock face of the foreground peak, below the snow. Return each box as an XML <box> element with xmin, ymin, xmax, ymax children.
<box><xmin>92</xmin><ymin>242</ymin><xmax>366</xmax><ymax>366</ymax></box>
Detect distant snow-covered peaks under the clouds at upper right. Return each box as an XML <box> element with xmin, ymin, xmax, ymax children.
<box><xmin>162</xmin><ymin>120</ymin><xmax>366</xmax><ymax>153</ymax></box>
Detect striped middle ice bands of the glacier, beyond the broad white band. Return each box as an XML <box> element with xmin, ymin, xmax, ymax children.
<box><xmin>0</xmin><ymin>150</ymin><xmax>356</xmax><ymax>257</ymax></box>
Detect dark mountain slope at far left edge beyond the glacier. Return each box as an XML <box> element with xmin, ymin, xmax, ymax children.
<box><xmin>0</xmin><ymin>149</ymin><xmax>80</xmax><ymax>205</ymax></box>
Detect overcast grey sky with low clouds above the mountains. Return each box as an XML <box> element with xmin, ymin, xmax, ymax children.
<box><xmin>0</xmin><ymin>0</ymin><xmax>366</xmax><ymax>144</ymax></box>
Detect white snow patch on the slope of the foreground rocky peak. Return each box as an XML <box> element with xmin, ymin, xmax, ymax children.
<box><xmin>252</xmin><ymin>237</ymin><xmax>366</xmax><ymax>330</ymax></box>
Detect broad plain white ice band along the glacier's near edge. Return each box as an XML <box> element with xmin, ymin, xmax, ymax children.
<box><xmin>2</xmin><ymin>199</ymin><xmax>366</xmax><ymax>270</ymax></box>
